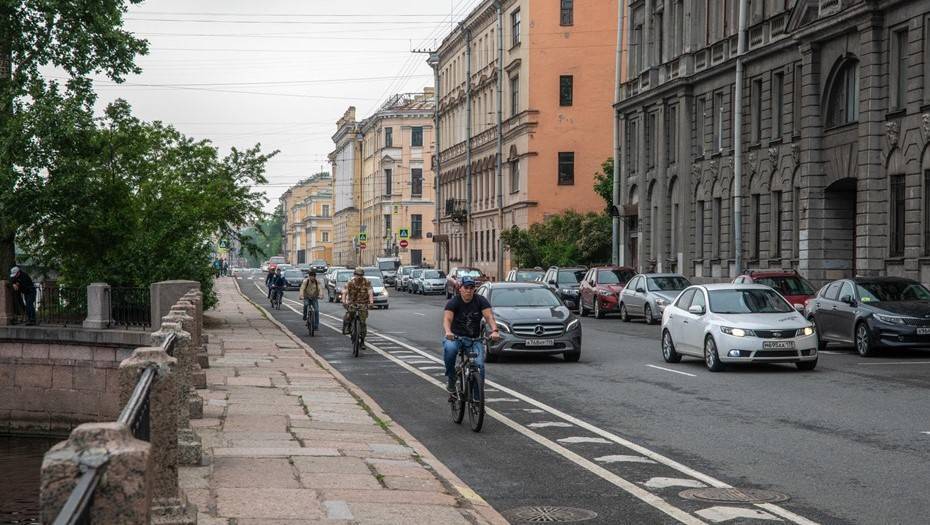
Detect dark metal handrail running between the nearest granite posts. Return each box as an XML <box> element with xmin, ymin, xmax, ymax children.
<box><xmin>53</xmin><ymin>334</ymin><xmax>177</xmax><ymax>525</ymax></box>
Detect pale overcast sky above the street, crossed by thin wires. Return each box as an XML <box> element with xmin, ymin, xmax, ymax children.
<box><xmin>89</xmin><ymin>0</ymin><xmax>480</xmax><ymax>211</ymax></box>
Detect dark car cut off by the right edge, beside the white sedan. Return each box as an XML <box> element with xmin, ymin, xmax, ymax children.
<box><xmin>805</xmin><ymin>277</ymin><xmax>930</xmax><ymax>356</ymax></box>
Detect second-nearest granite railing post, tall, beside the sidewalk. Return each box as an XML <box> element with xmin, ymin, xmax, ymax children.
<box><xmin>119</xmin><ymin>347</ymin><xmax>197</xmax><ymax>525</ymax></box>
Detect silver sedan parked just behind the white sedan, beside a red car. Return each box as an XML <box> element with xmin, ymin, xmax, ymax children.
<box><xmin>620</xmin><ymin>273</ymin><xmax>691</xmax><ymax>324</ymax></box>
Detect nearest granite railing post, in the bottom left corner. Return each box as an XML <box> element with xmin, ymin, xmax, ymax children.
<box><xmin>39</xmin><ymin>423</ymin><xmax>152</xmax><ymax>525</ymax></box>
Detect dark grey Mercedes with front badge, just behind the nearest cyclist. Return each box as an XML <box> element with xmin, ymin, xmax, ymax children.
<box><xmin>477</xmin><ymin>282</ymin><xmax>581</xmax><ymax>362</ymax></box>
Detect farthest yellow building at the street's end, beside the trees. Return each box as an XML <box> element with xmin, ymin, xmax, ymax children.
<box><xmin>281</xmin><ymin>173</ymin><xmax>335</xmax><ymax>266</ymax></box>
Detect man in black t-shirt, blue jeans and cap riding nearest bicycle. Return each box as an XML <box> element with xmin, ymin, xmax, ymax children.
<box><xmin>442</xmin><ymin>276</ymin><xmax>500</xmax><ymax>394</ymax></box>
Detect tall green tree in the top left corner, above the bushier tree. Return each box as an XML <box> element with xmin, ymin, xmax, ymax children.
<box><xmin>0</xmin><ymin>0</ymin><xmax>147</xmax><ymax>271</ymax></box>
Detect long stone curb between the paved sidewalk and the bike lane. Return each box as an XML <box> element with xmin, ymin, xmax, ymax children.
<box><xmin>232</xmin><ymin>277</ymin><xmax>509</xmax><ymax>525</ymax></box>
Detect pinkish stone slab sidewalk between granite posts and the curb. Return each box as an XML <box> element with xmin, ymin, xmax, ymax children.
<box><xmin>180</xmin><ymin>278</ymin><xmax>507</xmax><ymax>525</ymax></box>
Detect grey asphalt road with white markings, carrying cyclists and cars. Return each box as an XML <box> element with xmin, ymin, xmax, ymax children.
<box><xmin>239</xmin><ymin>278</ymin><xmax>930</xmax><ymax>524</ymax></box>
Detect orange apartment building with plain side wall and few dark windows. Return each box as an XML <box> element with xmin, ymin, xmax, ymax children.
<box><xmin>433</xmin><ymin>0</ymin><xmax>618</xmax><ymax>278</ymax></box>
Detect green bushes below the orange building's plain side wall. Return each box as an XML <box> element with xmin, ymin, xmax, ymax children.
<box><xmin>501</xmin><ymin>211</ymin><xmax>611</xmax><ymax>268</ymax></box>
